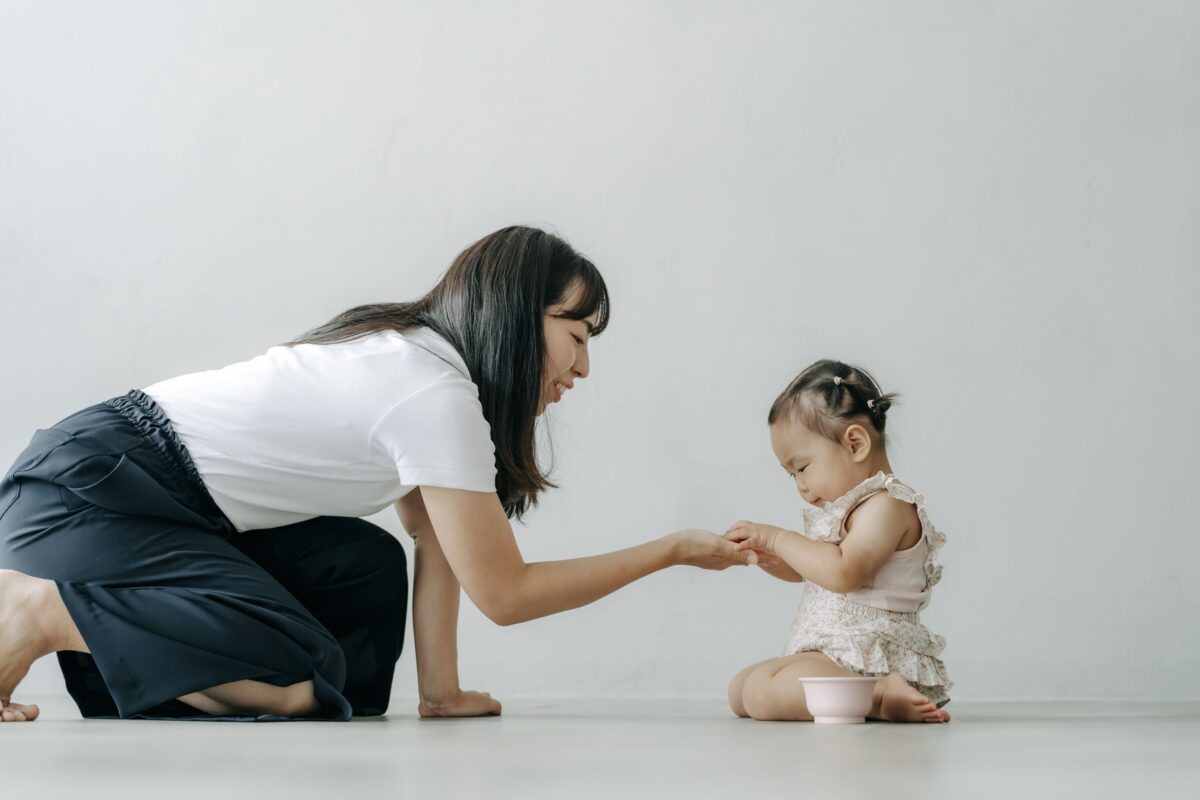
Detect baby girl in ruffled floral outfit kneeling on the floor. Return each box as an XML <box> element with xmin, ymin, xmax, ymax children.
<box><xmin>726</xmin><ymin>361</ymin><xmax>950</xmax><ymax>722</ymax></box>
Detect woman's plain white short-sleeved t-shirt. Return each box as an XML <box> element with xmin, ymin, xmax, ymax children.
<box><xmin>144</xmin><ymin>329</ymin><xmax>496</xmax><ymax>531</ymax></box>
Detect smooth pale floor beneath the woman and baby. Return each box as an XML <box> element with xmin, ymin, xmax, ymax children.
<box><xmin>0</xmin><ymin>697</ymin><xmax>1200</xmax><ymax>800</ymax></box>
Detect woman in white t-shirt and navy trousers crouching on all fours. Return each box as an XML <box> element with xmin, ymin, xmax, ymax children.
<box><xmin>0</xmin><ymin>227</ymin><xmax>740</xmax><ymax>722</ymax></box>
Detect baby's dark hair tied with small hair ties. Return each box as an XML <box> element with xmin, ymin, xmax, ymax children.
<box><xmin>767</xmin><ymin>359</ymin><xmax>899</xmax><ymax>446</ymax></box>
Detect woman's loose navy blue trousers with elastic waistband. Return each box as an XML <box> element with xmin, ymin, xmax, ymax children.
<box><xmin>0</xmin><ymin>390</ymin><xmax>408</xmax><ymax>720</ymax></box>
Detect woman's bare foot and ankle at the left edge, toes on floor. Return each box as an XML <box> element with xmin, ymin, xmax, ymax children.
<box><xmin>0</xmin><ymin>570</ymin><xmax>58</xmax><ymax>722</ymax></box>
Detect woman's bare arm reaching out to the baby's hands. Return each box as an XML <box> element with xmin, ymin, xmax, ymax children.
<box><xmin>421</xmin><ymin>486</ymin><xmax>748</xmax><ymax>625</ymax></box>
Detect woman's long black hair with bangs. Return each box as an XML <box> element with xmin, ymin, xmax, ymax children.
<box><xmin>287</xmin><ymin>225</ymin><xmax>608</xmax><ymax>518</ymax></box>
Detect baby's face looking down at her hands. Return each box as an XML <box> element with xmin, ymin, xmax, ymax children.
<box><xmin>770</xmin><ymin>420</ymin><xmax>862</xmax><ymax>506</ymax></box>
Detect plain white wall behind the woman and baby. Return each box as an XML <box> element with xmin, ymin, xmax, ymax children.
<box><xmin>0</xmin><ymin>0</ymin><xmax>1200</xmax><ymax>698</ymax></box>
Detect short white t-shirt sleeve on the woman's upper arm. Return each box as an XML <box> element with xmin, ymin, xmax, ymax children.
<box><xmin>371</xmin><ymin>379</ymin><xmax>496</xmax><ymax>492</ymax></box>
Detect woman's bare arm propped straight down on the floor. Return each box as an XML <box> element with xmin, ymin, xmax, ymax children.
<box><xmin>396</xmin><ymin>489</ymin><xmax>500</xmax><ymax>717</ymax></box>
